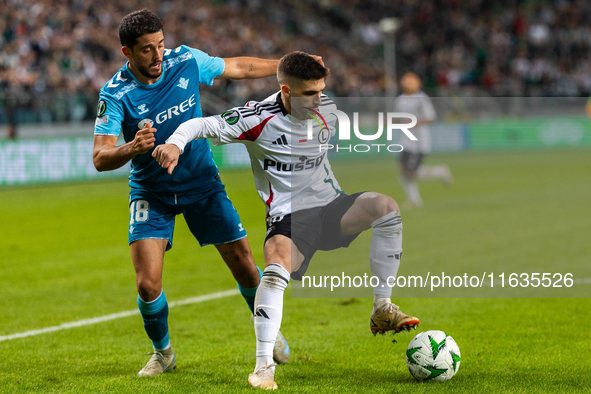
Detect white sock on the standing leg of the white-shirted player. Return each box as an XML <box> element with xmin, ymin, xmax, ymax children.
<box><xmin>254</xmin><ymin>264</ymin><xmax>289</xmax><ymax>371</ymax></box>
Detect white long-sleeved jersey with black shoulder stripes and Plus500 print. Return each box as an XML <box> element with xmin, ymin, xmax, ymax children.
<box><xmin>166</xmin><ymin>92</ymin><xmax>344</xmax><ymax>222</ymax></box>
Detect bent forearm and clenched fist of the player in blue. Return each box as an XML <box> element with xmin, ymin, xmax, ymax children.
<box><xmin>92</xmin><ymin>123</ymin><xmax>156</xmax><ymax>171</ymax></box>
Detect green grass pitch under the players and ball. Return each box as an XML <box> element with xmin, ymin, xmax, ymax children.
<box><xmin>0</xmin><ymin>149</ymin><xmax>591</xmax><ymax>393</ymax></box>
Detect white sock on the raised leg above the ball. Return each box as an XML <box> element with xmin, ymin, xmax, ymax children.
<box><xmin>369</xmin><ymin>211</ymin><xmax>402</xmax><ymax>312</ymax></box>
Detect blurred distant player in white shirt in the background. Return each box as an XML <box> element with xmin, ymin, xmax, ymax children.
<box><xmin>395</xmin><ymin>72</ymin><xmax>453</xmax><ymax>208</ymax></box>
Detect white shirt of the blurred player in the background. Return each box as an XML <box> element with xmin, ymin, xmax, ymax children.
<box><xmin>394</xmin><ymin>90</ymin><xmax>437</xmax><ymax>154</ymax></box>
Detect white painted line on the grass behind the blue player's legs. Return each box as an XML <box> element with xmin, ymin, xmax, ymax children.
<box><xmin>0</xmin><ymin>289</ymin><xmax>240</xmax><ymax>342</ymax></box>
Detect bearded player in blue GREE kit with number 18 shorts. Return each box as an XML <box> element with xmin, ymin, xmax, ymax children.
<box><xmin>93</xmin><ymin>10</ymin><xmax>289</xmax><ymax>376</ymax></box>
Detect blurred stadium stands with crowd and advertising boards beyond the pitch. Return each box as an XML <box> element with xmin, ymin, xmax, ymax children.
<box><xmin>0</xmin><ymin>0</ymin><xmax>591</xmax><ymax>186</ymax></box>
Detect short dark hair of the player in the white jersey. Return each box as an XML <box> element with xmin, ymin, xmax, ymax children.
<box><xmin>277</xmin><ymin>51</ymin><xmax>330</xmax><ymax>83</ymax></box>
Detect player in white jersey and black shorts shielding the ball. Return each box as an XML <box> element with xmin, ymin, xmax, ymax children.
<box><xmin>153</xmin><ymin>52</ymin><xmax>419</xmax><ymax>389</ymax></box>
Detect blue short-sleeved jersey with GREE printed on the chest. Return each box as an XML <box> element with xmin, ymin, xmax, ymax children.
<box><xmin>94</xmin><ymin>45</ymin><xmax>225</xmax><ymax>194</ymax></box>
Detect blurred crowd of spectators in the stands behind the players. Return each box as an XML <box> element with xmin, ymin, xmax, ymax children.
<box><xmin>0</xmin><ymin>0</ymin><xmax>591</xmax><ymax>123</ymax></box>
